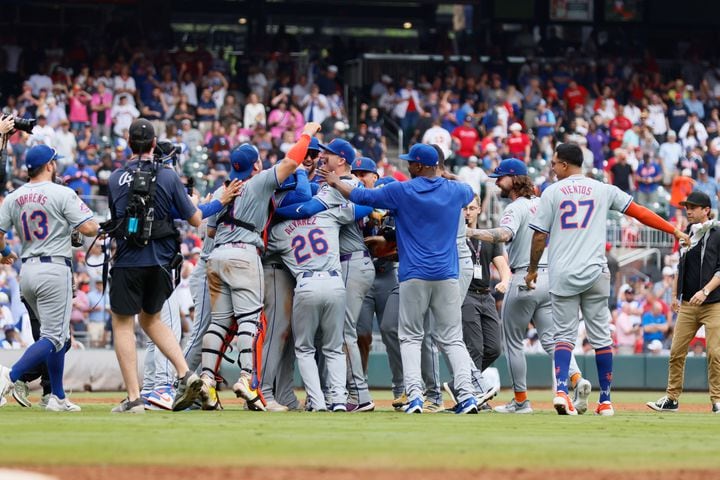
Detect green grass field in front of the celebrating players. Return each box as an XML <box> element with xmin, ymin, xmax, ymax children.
<box><xmin>0</xmin><ymin>391</ymin><xmax>720</xmax><ymax>478</ymax></box>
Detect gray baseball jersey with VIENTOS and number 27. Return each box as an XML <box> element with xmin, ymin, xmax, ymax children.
<box><xmin>530</xmin><ymin>175</ymin><xmax>632</xmax><ymax>296</ymax></box>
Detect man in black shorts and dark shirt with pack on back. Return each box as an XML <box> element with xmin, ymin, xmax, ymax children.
<box><xmin>109</xmin><ymin>119</ymin><xmax>202</xmax><ymax>413</ymax></box>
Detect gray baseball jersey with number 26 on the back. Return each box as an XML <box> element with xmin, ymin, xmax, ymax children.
<box><xmin>268</xmin><ymin>203</ymin><xmax>355</xmax><ymax>277</ymax></box>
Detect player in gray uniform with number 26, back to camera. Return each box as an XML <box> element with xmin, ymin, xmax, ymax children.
<box><xmin>269</xmin><ymin>204</ymin><xmax>362</xmax><ymax>412</ymax></box>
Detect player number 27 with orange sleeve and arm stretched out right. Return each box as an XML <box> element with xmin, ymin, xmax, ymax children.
<box><xmin>525</xmin><ymin>143</ymin><xmax>689</xmax><ymax>416</ymax></box>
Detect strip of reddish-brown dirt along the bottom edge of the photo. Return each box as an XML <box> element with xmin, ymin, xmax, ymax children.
<box><xmin>25</xmin><ymin>466</ymin><xmax>718</xmax><ymax>480</ymax></box>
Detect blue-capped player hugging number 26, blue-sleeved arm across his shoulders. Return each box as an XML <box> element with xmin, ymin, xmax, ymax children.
<box><xmin>278</xmin><ymin>138</ymin><xmax>375</xmax><ymax>411</ymax></box>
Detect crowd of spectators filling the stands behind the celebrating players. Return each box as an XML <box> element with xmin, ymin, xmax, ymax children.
<box><xmin>0</xmin><ymin>33</ymin><xmax>720</xmax><ymax>352</ymax></box>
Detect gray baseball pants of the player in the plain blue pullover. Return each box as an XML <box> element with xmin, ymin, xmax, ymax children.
<box><xmin>398</xmin><ymin>279</ymin><xmax>473</xmax><ymax>402</ymax></box>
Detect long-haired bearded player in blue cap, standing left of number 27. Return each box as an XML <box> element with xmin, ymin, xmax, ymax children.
<box><xmin>468</xmin><ymin>158</ymin><xmax>592</xmax><ymax>414</ymax></box>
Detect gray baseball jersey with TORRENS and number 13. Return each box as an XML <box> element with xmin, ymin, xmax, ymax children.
<box><xmin>0</xmin><ymin>182</ymin><xmax>93</xmax><ymax>258</ymax></box>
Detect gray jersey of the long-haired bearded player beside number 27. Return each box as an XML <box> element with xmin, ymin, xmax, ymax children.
<box><xmin>500</xmin><ymin>197</ymin><xmax>548</xmax><ymax>270</ymax></box>
